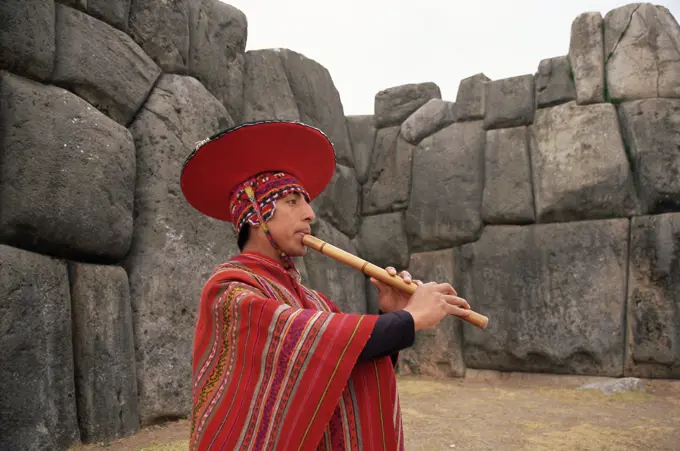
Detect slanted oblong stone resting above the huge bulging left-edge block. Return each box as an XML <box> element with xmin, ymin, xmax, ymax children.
<box><xmin>52</xmin><ymin>5</ymin><xmax>160</xmax><ymax>126</ymax></box>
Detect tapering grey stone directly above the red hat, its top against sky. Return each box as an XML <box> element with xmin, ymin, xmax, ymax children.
<box><xmin>242</xmin><ymin>49</ymin><xmax>300</xmax><ymax>122</ymax></box>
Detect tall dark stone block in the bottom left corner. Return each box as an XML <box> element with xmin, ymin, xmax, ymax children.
<box><xmin>0</xmin><ymin>245</ymin><xmax>80</xmax><ymax>450</ymax></box>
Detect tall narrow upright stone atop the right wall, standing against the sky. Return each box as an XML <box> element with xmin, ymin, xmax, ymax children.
<box><xmin>569</xmin><ymin>12</ymin><xmax>605</xmax><ymax>105</ymax></box>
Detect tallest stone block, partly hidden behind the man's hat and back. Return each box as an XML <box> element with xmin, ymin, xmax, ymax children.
<box><xmin>125</xmin><ymin>75</ymin><xmax>238</xmax><ymax>424</ymax></box>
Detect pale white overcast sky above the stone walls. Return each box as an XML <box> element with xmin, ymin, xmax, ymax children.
<box><xmin>226</xmin><ymin>0</ymin><xmax>680</xmax><ymax>115</ymax></box>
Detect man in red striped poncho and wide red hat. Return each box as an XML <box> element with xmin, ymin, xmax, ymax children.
<box><xmin>181</xmin><ymin>121</ymin><xmax>470</xmax><ymax>451</ymax></box>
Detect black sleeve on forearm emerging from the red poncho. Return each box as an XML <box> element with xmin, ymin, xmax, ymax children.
<box><xmin>359</xmin><ymin>310</ymin><xmax>415</xmax><ymax>362</ymax></box>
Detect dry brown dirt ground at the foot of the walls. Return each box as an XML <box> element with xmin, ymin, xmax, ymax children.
<box><xmin>69</xmin><ymin>371</ymin><xmax>680</xmax><ymax>451</ymax></box>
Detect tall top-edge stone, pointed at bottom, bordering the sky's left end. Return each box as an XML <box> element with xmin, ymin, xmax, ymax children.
<box><xmin>188</xmin><ymin>0</ymin><xmax>248</xmax><ymax>123</ymax></box>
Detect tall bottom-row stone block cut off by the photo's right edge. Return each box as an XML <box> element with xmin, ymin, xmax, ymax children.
<box><xmin>625</xmin><ymin>213</ymin><xmax>680</xmax><ymax>378</ymax></box>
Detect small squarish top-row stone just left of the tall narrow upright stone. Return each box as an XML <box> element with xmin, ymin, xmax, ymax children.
<box><xmin>535</xmin><ymin>56</ymin><xmax>576</xmax><ymax>108</ymax></box>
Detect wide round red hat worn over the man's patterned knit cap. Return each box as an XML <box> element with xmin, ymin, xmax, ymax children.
<box><xmin>180</xmin><ymin>120</ymin><xmax>336</xmax><ymax>222</ymax></box>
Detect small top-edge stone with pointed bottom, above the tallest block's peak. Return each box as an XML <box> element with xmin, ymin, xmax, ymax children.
<box><xmin>128</xmin><ymin>0</ymin><xmax>192</xmax><ymax>74</ymax></box>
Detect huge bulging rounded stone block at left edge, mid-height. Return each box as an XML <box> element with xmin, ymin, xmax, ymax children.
<box><xmin>0</xmin><ymin>74</ymin><xmax>136</xmax><ymax>261</ymax></box>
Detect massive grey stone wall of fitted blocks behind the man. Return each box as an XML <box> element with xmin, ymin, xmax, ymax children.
<box><xmin>0</xmin><ymin>0</ymin><xmax>680</xmax><ymax>449</ymax></box>
